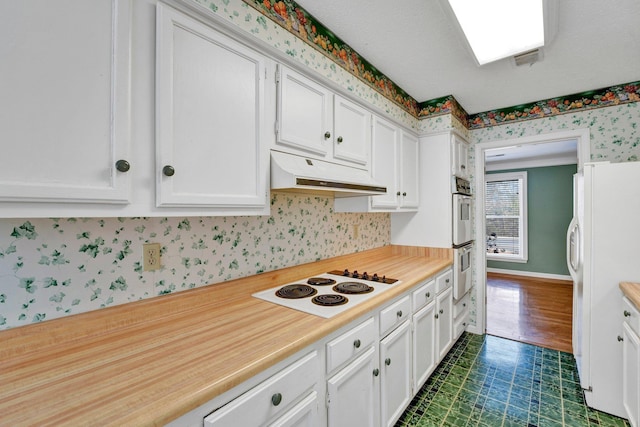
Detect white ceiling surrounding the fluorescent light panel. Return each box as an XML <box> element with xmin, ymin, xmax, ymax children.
<box><xmin>296</xmin><ymin>0</ymin><xmax>640</xmax><ymax>114</ymax></box>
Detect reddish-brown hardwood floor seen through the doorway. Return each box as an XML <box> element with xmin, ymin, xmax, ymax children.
<box><xmin>487</xmin><ymin>273</ymin><xmax>573</xmax><ymax>353</ymax></box>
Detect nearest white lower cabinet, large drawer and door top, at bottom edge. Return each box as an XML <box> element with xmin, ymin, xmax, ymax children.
<box><xmin>204</xmin><ymin>351</ymin><xmax>321</xmax><ymax>427</ymax></box>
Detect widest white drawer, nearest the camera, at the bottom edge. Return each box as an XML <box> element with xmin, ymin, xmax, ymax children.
<box><xmin>204</xmin><ymin>351</ymin><xmax>322</xmax><ymax>427</ymax></box>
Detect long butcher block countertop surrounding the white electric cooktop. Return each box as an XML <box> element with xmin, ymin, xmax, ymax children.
<box><xmin>0</xmin><ymin>246</ymin><xmax>453</xmax><ymax>426</ymax></box>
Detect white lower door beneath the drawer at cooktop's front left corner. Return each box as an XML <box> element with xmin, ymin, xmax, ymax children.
<box><xmin>327</xmin><ymin>346</ymin><xmax>380</xmax><ymax>427</ymax></box>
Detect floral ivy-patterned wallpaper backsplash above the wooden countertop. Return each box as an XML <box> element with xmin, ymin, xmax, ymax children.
<box><xmin>0</xmin><ymin>193</ymin><xmax>391</xmax><ymax>329</ymax></box>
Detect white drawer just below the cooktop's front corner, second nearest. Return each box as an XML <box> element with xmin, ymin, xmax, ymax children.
<box><xmin>327</xmin><ymin>317</ymin><xmax>378</xmax><ymax>373</ymax></box>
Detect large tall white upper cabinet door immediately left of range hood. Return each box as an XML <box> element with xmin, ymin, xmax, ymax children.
<box><xmin>156</xmin><ymin>4</ymin><xmax>268</xmax><ymax>208</ymax></box>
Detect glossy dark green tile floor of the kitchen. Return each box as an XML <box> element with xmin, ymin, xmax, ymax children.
<box><xmin>396</xmin><ymin>332</ymin><xmax>629</xmax><ymax>427</ymax></box>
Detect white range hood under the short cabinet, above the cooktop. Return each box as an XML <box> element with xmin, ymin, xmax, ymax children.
<box><xmin>271</xmin><ymin>151</ymin><xmax>387</xmax><ymax>197</ymax></box>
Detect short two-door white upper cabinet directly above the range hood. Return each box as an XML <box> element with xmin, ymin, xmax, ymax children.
<box><xmin>276</xmin><ymin>66</ymin><xmax>371</xmax><ymax>170</ymax></box>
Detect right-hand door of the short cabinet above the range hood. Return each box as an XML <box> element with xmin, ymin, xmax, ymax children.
<box><xmin>333</xmin><ymin>95</ymin><xmax>371</xmax><ymax>168</ymax></box>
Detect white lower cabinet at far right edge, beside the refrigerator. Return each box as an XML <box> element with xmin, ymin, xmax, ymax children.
<box><xmin>622</xmin><ymin>298</ymin><xmax>640</xmax><ymax>427</ymax></box>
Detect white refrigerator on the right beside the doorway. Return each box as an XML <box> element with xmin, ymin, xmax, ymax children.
<box><xmin>567</xmin><ymin>162</ymin><xmax>640</xmax><ymax>418</ymax></box>
